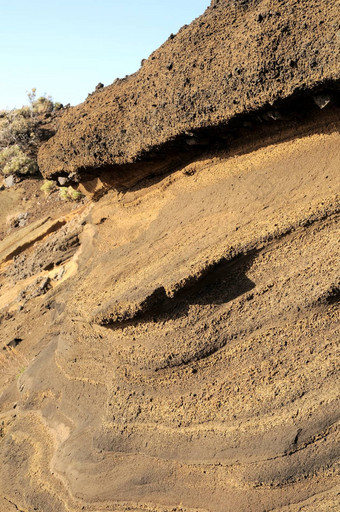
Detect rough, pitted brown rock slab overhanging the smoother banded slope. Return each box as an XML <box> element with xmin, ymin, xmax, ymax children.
<box><xmin>39</xmin><ymin>0</ymin><xmax>340</xmax><ymax>177</ymax></box>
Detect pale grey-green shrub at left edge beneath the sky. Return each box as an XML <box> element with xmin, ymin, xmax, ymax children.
<box><xmin>0</xmin><ymin>89</ymin><xmax>62</xmax><ymax>176</ymax></box>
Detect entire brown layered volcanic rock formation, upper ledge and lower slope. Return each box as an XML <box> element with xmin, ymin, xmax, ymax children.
<box><xmin>0</xmin><ymin>0</ymin><xmax>340</xmax><ymax>512</ymax></box>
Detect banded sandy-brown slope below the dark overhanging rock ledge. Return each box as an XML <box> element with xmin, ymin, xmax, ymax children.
<box><xmin>0</xmin><ymin>108</ymin><xmax>340</xmax><ymax>512</ymax></box>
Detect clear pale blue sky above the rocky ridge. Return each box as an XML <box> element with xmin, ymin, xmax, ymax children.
<box><xmin>0</xmin><ymin>0</ymin><xmax>210</xmax><ymax>109</ymax></box>
